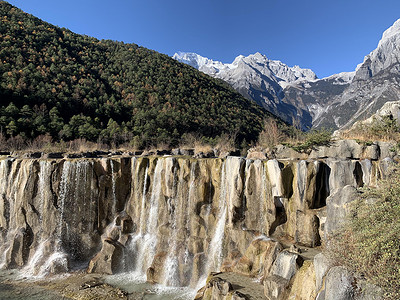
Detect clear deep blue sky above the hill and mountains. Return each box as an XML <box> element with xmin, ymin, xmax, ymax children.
<box><xmin>8</xmin><ymin>0</ymin><xmax>400</xmax><ymax>78</ymax></box>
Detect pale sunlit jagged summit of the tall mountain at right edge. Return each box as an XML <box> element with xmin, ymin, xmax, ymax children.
<box><xmin>354</xmin><ymin>19</ymin><xmax>400</xmax><ymax>80</ymax></box>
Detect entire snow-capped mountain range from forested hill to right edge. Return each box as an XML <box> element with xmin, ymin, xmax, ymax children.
<box><xmin>173</xmin><ymin>19</ymin><xmax>400</xmax><ymax>129</ymax></box>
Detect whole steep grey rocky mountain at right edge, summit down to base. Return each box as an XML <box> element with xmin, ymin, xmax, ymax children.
<box><xmin>313</xmin><ymin>19</ymin><xmax>400</xmax><ymax>128</ymax></box>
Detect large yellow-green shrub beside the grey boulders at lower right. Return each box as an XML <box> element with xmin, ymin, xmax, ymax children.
<box><xmin>328</xmin><ymin>165</ymin><xmax>400</xmax><ymax>300</ymax></box>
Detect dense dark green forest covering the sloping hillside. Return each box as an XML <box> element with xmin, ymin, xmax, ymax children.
<box><xmin>0</xmin><ymin>1</ymin><xmax>276</xmax><ymax>147</ymax></box>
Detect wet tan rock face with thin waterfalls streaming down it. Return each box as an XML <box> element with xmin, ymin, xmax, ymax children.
<box><xmin>0</xmin><ymin>156</ymin><xmax>385</xmax><ymax>289</ymax></box>
